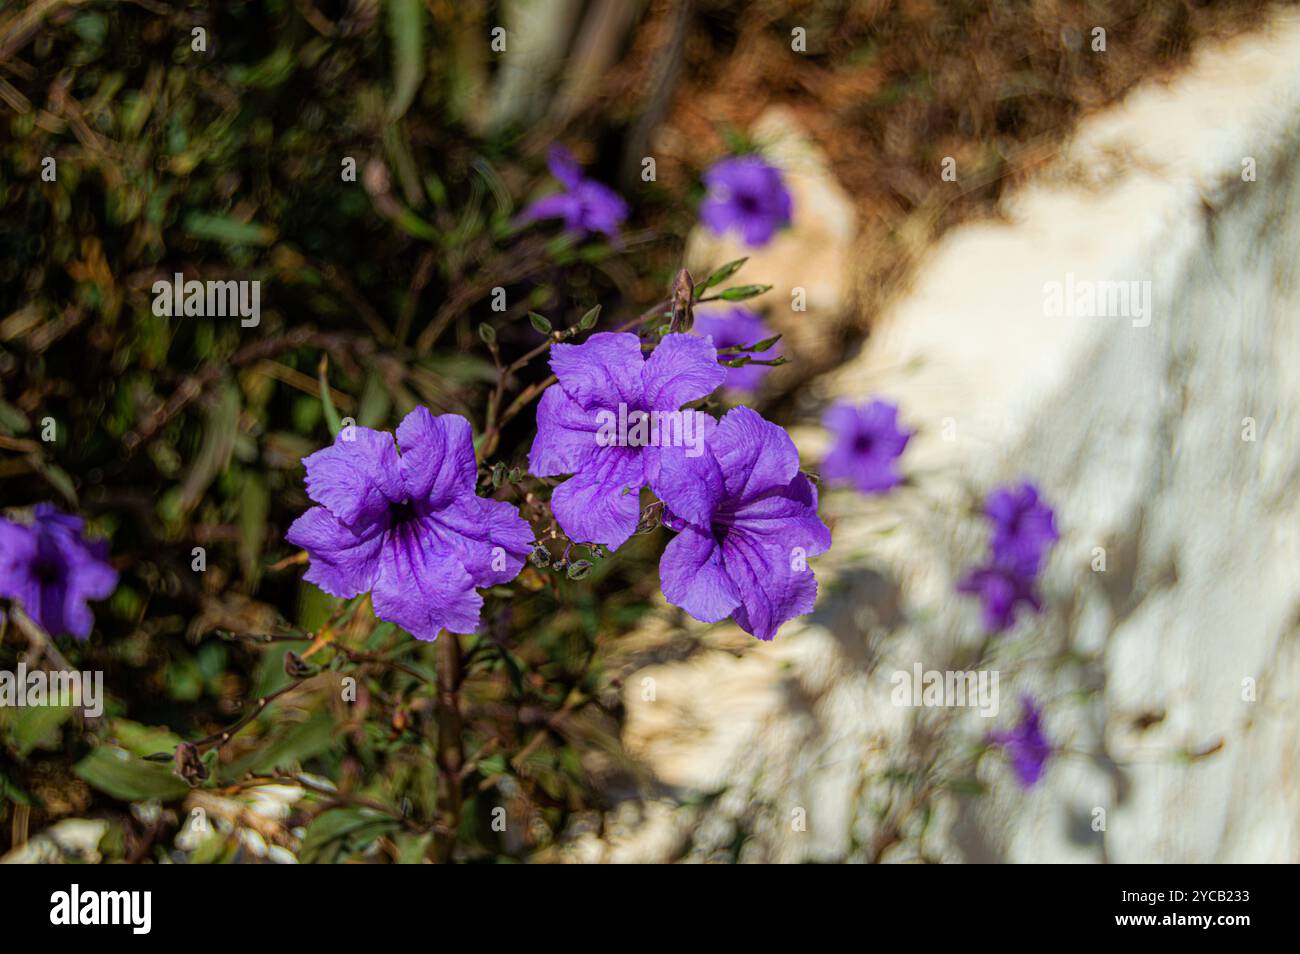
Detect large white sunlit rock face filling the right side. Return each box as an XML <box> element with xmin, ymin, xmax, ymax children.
<box><xmin>576</xmin><ymin>17</ymin><xmax>1300</xmax><ymax>862</ymax></box>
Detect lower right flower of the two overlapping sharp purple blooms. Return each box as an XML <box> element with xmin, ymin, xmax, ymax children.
<box><xmin>650</xmin><ymin>407</ymin><xmax>831</xmax><ymax>639</ymax></box>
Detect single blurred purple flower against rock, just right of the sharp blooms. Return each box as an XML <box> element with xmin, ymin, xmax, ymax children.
<box><xmin>822</xmin><ymin>400</ymin><xmax>911</xmax><ymax>494</ymax></box>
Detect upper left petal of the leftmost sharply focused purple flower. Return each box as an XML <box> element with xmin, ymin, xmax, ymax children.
<box><xmin>303</xmin><ymin>426</ymin><xmax>404</xmax><ymax>528</ymax></box>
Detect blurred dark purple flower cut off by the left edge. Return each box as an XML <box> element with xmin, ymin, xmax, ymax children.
<box><xmin>0</xmin><ymin>503</ymin><xmax>117</xmax><ymax>639</ymax></box>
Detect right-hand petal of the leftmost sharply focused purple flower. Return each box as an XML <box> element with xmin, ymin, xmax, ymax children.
<box><xmin>424</xmin><ymin>496</ymin><xmax>533</xmax><ymax>586</ymax></box>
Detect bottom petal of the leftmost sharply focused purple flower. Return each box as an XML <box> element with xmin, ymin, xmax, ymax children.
<box><xmin>372</xmin><ymin>521</ymin><xmax>484</xmax><ymax>641</ymax></box>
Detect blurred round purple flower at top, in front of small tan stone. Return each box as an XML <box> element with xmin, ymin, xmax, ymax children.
<box><xmin>699</xmin><ymin>156</ymin><xmax>792</xmax><ymax>248</ymax></box>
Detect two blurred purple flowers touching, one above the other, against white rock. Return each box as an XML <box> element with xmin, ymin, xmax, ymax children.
<box><xmin>957</xmin><ymin>481</ymin><xmax>1060</xmax><ymax>633</ymax></box>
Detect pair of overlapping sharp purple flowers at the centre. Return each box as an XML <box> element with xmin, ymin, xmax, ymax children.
<box><xmin>529</xmin><ymin>334</ymin><xmax>831</xmax><ymax>639</ymax></box>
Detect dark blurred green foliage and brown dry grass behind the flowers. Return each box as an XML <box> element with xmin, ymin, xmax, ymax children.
<box><xmin>0</xmin><ymin>0</ymin><xmax>1260</xmax><ymax>862</ymax></box>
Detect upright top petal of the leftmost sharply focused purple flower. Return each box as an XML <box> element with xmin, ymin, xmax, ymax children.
<box><xmin>398</xmin><ymin>406</ymin><xmax>478</xmax><ymax>508</ymax></box>
